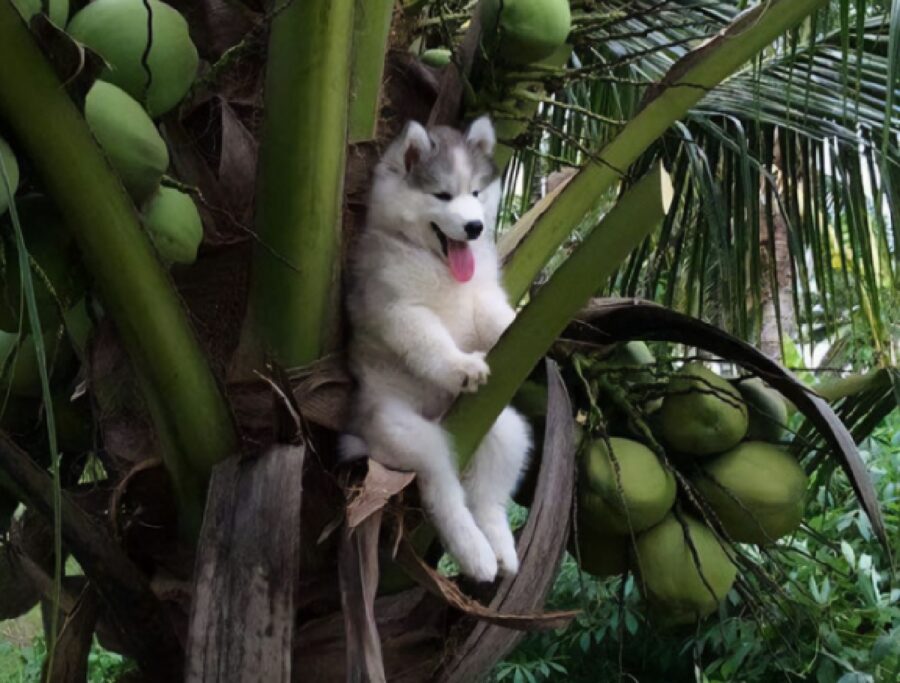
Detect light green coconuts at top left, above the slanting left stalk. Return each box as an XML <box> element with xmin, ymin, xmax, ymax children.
<box><xmin>7</xmin><ymin>0</ymin><xmax>203</xmax><ymax>264</ymax></box>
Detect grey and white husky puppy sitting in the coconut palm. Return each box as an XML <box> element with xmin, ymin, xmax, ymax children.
<box><xmin>342</xmin><ymin>117</ymin><xmax>531</xmax><ymax>581</ymax></box>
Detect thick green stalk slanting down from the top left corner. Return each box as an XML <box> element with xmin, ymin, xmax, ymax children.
<box><xmin>0</xmin><ymin>0</ymin><xmax>236</xmax><ymax>526</ymax></box>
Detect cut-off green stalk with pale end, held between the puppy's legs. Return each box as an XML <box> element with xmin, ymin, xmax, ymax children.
<box><xmin>444</xmin><ymin>164</ymin><xmax>673</xmax><ymax>470</ymax></box>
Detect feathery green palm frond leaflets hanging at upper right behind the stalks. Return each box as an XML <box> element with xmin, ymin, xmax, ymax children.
<box><xmin>496</xmin><ymin>0</ymin><xmax>900</xmax><ymax>362</ymax></box>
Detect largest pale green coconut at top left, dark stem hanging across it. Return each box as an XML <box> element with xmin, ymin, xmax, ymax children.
<box><xmin>67</xmin><ymin>0</ymin><xmax>198</xmax><ymax>118</ymax></box>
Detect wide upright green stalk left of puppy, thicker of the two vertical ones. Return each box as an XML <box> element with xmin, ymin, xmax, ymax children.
<box><xmin>246</xmin><ymin>0</ymin><xmax>355</xmax><ymax>367</ymax></box>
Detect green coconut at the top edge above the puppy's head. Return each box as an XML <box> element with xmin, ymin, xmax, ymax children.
<box><xmin>481</xmin><ymin>0</ymin><xmax>572</xmax><ymax>64</ymax></box>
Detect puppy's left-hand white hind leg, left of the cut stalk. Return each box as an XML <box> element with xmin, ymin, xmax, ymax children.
<box><xmin>365</xmin><ymin>402</ymin><xmax>497</xmax><ymax>581</ymax></box>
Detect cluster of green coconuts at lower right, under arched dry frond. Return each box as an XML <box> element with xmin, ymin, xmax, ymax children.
<box><xmin>570</xmin><ymin>342</ymin><xmax>807</xmax><ymax>624</ymax></box>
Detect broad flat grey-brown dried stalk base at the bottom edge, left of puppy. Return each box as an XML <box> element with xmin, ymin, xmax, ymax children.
<box><xmin>185</xmin><ymin>446</ymin><xmax>306</xmax><ymax>683</ymax></box>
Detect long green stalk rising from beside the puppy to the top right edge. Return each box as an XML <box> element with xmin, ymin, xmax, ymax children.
<box><xmin>504</xmin><ymin>0</ymin><xmax>827</xmax><ymax>301</ymax></box>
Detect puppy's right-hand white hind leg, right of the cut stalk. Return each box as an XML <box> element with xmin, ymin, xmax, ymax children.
<box><xmin>463</xmin><ymin>408</ymin><xmax>531</xmax><ymax>575</ymax></box>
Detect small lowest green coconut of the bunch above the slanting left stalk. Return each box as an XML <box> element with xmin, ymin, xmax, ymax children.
<box><xmin>143</xmin><ymin>187</ymin><xmax>203</xmax><ymax>263</ymax></box>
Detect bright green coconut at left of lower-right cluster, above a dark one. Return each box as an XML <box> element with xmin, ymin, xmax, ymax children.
<box><xmin>578</xmin><ymin>437</ymin><xmax>675</xmax><ymax>535</ymax></box>
